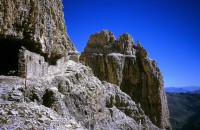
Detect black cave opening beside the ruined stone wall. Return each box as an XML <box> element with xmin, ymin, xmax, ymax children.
<box><xmin>0</xmin><ymin>39</ymin><xmax>21</xmax><ymax>76</ymax></box>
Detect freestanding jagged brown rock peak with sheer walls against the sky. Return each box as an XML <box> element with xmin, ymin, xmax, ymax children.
<box><xmin>81</xmin><ymin>30</ymin><xmax>171</xmax><ymax>129</ymax></box>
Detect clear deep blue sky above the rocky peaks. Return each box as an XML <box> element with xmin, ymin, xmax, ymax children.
<box><xmin>63</xmin><ymin>0</ymin><xmax>200</xmax><ymax>87</ymax></box>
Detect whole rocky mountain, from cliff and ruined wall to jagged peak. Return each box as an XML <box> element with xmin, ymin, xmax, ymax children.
<box><xmin>0</xmin><ymin>0</ymin><xmax>170</xmax><ymax>130</ymax></box>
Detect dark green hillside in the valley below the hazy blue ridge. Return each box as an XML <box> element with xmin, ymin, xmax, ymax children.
<box><xmin>166</xmin><ymin>91</ymin><xmax>200</xmax><ymax>130</ymax></box>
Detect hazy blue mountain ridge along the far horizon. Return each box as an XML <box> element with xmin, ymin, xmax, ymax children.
<box><xmin>165</xmin><ymin>86</ymin><xmax>200</xmax><ymax>93</ymax></box>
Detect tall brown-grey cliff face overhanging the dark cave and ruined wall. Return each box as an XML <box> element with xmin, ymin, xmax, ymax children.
<box><xmin>0</xmin><ymin>0</ymin><xmax>75</xmax><ymax>59</ymax></box>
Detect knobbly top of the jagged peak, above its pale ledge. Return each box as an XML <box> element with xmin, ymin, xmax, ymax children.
<box><xmin>84</xmin><ymin>30</ymin><xmax>138</xmax><ymax>55</ymax></box>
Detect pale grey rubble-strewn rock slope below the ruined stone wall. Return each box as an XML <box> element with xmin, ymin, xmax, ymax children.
<box><xmin>0</xmin><ymin>61</ymin><xmax>158</xmax><ymax>130</ymax></box>
